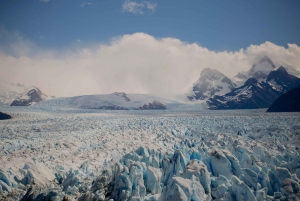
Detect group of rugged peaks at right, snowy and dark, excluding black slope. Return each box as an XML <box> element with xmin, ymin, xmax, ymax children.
<box><xmin>187</xmin><ymin>56</ymin><xmax>300</xmax><ymax>109</ymax></box>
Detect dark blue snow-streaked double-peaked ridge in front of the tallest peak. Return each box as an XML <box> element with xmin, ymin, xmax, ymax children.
<box><xmin>207</xmin><ymin>67</ymin><xmax>300</xmax><ymax>109</ymax></box>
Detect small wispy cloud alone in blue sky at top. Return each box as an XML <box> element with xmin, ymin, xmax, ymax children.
<box><xmin>122</xmin><ymin>0</ymin><xmax>156</xmax><ymax>15</ymax></box>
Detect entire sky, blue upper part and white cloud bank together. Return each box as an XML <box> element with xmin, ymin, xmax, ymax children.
<box><xmin>0</xmin><ymin>0</ymin><xmax>300</xmax><ymax>96</ymax></box>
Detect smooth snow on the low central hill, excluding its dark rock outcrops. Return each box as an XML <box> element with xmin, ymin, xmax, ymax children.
<box><xmin>34</xmin><ymin>93</ymin><xmax>207</xmax><ymax>110</ymax></box>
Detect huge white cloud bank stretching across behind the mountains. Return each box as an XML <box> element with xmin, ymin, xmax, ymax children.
<box><xmin>0</xmin><ymin>33</ymin><xmax>300</xmax><ymax>96</ymax></box>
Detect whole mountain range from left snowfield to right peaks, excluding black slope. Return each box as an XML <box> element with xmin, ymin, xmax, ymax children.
<box><xmin>0</xmin><ymin>56</ymin><xmax>300</xmax><ymax>110</ymax></box>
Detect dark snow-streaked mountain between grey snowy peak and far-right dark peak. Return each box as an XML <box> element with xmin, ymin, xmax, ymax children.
<box><xmin>207</xmin><ymin>78</ymin><xmax>281</xmax><ymax>109</ymax></box>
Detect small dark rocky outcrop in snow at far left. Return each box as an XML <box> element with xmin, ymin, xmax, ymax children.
<box><xmin>10</xmin><ymin>88</ymin><xmax>44</xmax><ymax>106</ymax></box>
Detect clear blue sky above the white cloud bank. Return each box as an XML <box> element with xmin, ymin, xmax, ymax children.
<box><xmin>0</xmin><ymin>0</ymin><xmax>300</xmax><ymax>51</ymax></box>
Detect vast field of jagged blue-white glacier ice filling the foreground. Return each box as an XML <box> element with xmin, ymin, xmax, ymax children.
<box><xmin>0</xmin><ymin>107</ymin><xmax>300</xmax><ymax>201</ymax></box>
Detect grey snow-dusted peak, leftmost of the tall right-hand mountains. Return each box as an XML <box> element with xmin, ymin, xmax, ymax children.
<box><xmin>187</xmin><ymin>68</ymin><xmax>236</xmax><ymax>100</ymax></box>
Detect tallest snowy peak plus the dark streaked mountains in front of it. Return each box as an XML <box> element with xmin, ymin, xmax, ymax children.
<box><xmin>200</xmin><ymin>56</ymin><xmax>300</xmax><ymax>109</ymax></box>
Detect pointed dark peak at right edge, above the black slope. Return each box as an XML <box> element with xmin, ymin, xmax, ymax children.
<box><xmin>267</xmin><ymin>66</ymin><xmax>300</xmax><ymax>93</ymax></box>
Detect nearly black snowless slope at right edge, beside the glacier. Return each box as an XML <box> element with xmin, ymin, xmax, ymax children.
<box><xmin>267</xmin><ymin>86</ymin><xmax>300</xmax><ymax>112</ymax></box>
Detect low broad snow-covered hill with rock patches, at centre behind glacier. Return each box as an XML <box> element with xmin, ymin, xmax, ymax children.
<box><xmin>34</xmin><ymin>92</ymin><xmax>190</xmax><ymax>110</ymax></box>
